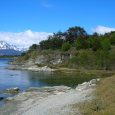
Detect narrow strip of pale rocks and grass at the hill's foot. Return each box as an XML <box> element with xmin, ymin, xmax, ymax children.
<box><xmin>8</xmin><ymin>64</ymin><xmax>115</xmax><ymax>76</ymax></box>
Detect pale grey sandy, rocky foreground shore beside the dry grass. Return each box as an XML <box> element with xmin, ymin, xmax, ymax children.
<box><xmin>0</xmin><ymin>80</ymin><xmax>95</xmax><ymax>115</ymax></box>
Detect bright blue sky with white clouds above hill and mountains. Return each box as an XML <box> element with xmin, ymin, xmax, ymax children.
<box><xmin>0</xmin><ymin>0</ymin><xmax>115</xmax><ymax>47</ymax></box>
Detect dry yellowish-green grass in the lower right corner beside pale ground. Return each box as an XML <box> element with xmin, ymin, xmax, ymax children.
<box><xmin>78</xmin><ymin>75</ymin><xmax>115</xmax><ymax>115</ymax></box>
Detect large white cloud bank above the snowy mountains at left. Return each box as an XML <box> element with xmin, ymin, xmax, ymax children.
<box><xmin>0</xmin><ymin>30</ymin><xmax>52</xmax><ymax>48</ymax></box>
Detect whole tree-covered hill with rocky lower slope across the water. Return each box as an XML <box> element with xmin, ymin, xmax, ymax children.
<box><xmin>15</xmin><ymin>27</ymin><xmax>115</xmax><ymax>70</ymax></box>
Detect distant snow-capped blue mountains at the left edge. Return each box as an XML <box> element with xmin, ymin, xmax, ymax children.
<box><xmin>0</xmin><ymin>41</ymin><xmax>23</xmax><ymax>56</ymax></box>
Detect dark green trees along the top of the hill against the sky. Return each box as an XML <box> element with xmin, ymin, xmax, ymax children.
<box><xmin>29</xmin><ymin>26</ymin><xmax>115</xmax><ymax>51</ymax></box>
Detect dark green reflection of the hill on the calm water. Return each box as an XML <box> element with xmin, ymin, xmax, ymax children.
<box><xmin>29</xmin><ymin>72</ymin><xmax>96</xmax><ymax>87</ymax></box>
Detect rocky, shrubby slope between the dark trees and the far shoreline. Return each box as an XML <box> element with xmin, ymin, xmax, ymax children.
<box><xmin>15</xmin><ymin>47</ymin><xmax>115</xmax><ymax>70</ymax></box>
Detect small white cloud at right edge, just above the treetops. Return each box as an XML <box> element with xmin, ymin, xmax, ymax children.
<box><xmin>93</xmin><ymin>26</ymin><xmax>115</xmax><ymax>34</ymax></box>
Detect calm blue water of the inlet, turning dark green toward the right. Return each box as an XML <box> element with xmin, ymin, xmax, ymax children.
<box><xmin>0</xmin><ymin>59</ymin><xmax>99</xmax><ymax>91</ymax></box>
